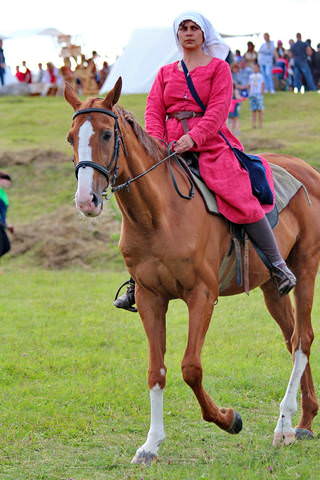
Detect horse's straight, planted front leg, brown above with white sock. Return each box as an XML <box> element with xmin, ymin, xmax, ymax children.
<box><xmin>131</xmin><ymin>287</ymin><xmax>168</xmax><ymax>465</ymax></box>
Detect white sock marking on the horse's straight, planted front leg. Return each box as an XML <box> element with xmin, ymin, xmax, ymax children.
<box><xmin>131</xmin><ymin>383</ymin><xmax>165</xmax><ymax>463</ymax></box>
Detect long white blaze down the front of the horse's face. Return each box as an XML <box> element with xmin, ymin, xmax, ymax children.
<box><xmin>76</xmin><ymin>120</ymin><xmax>94</xmax><ymax>206</ymax></box>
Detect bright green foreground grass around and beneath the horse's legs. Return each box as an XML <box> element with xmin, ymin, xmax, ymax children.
<box><xmin>0</xmin><ymin>271</ymin><xmax>320</xmax><ymax>480</ymax></box>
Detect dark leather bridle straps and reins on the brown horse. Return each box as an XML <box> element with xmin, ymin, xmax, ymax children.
<box><xmin>72</xmin><ymin>108</ymin><xmax>194</xmax><ymax>200</ymax></box>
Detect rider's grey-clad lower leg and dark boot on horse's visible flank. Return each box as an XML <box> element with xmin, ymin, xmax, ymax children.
<box><xmin>244</xmin><ymin>217</ymin><xmax>296</xmax><ymax>296</ymax></box>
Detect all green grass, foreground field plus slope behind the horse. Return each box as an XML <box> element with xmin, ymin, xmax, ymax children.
<box><xmin>0</xmin><ymin>93</ymin><xmax>320</xmax><ymax>480</ymax></box>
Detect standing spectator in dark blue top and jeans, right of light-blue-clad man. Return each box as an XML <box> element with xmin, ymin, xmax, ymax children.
<box><xmin>290</xmin><ymin>33</ymin><xmax>316</xmax><ymax>93</ymax></box>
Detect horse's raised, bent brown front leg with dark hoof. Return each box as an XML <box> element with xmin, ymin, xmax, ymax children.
<box><xmin>182</xmin><ymin>285</ymin><xmax>242</xmax><ymax>433</ymax></box>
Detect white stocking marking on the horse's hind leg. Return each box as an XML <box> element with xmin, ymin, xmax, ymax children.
<box><xmin>274</xmin><ymin>348</ymin><xmax>308</xmax><ymax>440</ymax></box>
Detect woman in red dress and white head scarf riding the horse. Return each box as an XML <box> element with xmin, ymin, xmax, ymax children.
<box><xmin>114</xmin><ymin>12</ymin><xmax>296</xmax><ymax>309</ymax></box>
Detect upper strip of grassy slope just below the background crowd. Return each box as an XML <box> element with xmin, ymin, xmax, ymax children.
<box><xmin>0</xmin><ymin>92</ymin><xmax>320</xmax><ymax>166</ymax></box>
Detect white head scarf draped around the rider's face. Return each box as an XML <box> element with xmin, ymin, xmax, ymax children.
<box><xmin>173</xmin><ymin>12</ymin><xmax>230</xmax><ymax>60</ymax></box>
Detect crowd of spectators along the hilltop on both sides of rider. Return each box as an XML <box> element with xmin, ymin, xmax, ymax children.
<box><xmin>0</xmin><ymin>33</ymin><xmax>320</xmax><ymax>98</ymax></box>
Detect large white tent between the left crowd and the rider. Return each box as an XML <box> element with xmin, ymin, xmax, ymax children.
<box><xmin>101</xmin><ymin>28</ymin><xmax>179</xmax><ymax>93</ymax></box>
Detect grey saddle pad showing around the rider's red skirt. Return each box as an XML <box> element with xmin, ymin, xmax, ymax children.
<box><xmin>192</xmin><ymin>163</ymin><xmax>305</xmax><ymax>215</ymax></box>
